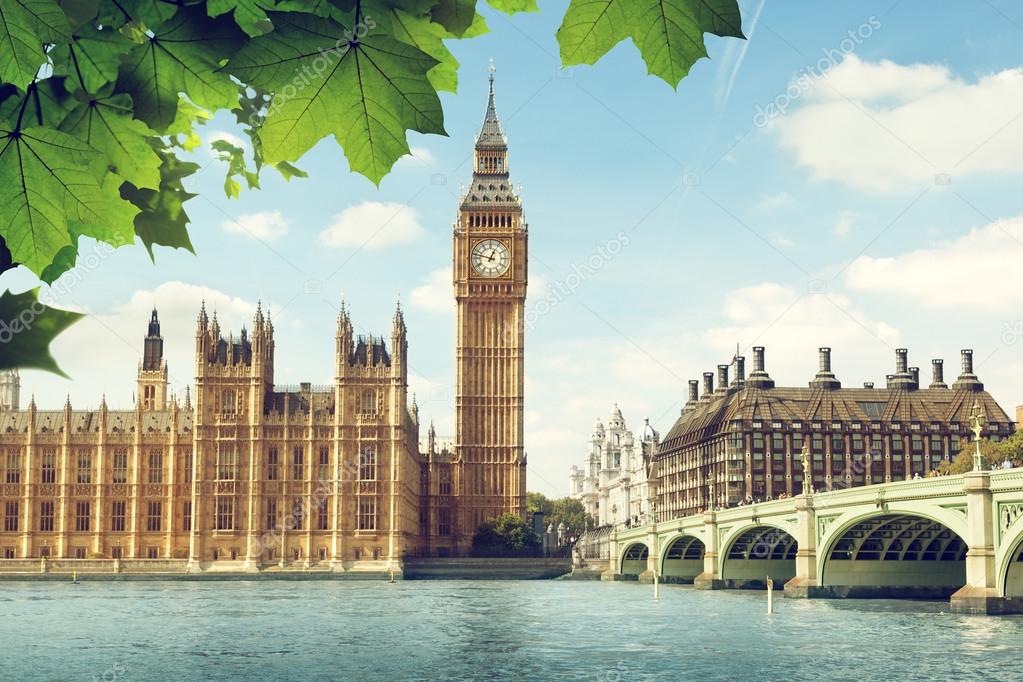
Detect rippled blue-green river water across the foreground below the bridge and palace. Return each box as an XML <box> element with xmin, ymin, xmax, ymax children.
<box><xmin>0</xmin><ymin>581</ymin><xmax>1023</xmax><ymax>682</ymax></box>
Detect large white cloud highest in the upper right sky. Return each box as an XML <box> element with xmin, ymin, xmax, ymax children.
<box><xmin>769</xmin><ymin>55</ymin><xmax>1023</xmax><ymax>192</ymax></box>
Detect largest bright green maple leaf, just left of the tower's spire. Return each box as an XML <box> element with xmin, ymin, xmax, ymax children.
<box><xmin>227</xmin><ymin>12</ymin><xmax>447</xmax><ymax>184</ymax></box>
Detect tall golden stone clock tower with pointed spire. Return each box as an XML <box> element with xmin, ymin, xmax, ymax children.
<box><xmin>452</xmin><ymin>65</ymin><xmax>527</xmax><ymax>549</ymax></box>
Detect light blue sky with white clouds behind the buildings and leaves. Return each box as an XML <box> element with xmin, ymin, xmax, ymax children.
<box><xmin>6</xmin><ymin>0</ymin><xmax>1023</xmax><ymax>494</ymax></box>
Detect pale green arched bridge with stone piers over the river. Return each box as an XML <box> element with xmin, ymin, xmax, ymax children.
<box><xmin>604</xmin><ymin>468</ymin><xmax>1023</xmax><ymax>613</ymax></box>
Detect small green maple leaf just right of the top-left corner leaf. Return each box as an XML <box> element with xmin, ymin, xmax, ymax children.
<box><xmin>50</xmin><ymin>25</ymin><xmax>132</xmax><ymax>92</ymax></box>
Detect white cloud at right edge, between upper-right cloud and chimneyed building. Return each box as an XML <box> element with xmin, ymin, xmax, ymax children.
<box><xmin>845</xmin><ymin>216</ymin><xmax>1023</xmax><ymax>316</ymax></box>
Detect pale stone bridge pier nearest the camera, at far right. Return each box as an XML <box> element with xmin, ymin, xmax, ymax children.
<box><xmin>951</xmin><ymin>471</ymin><xmax>1018</xmax><ymax>615</ymax></box>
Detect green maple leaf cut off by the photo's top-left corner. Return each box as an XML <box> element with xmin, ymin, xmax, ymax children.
<box><xmin>0</xmin><ymin>0</ymin><xmax>71</xmax><ymax>88</ymax></box>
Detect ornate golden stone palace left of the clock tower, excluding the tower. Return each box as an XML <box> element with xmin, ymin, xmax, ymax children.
<box><xmin>0</xmin><ymin>308</ymin><xmax>429</xmax><ymax>570</ymax></box>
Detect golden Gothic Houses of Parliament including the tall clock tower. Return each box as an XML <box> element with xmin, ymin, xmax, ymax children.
<box><xmin>0</xmin><ymin>73</ymin><xmax>527</xmax><ymax>572</ymax></box>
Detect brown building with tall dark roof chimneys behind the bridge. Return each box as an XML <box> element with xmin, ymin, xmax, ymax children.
<box><xmin>657</xmin><ymin>347</ymin><xmax>1013</xmax><ymax>518</ymax></box>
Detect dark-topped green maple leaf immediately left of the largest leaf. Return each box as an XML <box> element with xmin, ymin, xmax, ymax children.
<box><xmin>117</xmin><ymin>7</ymin><xmax>244</xmax><ymax>133</ymax></box>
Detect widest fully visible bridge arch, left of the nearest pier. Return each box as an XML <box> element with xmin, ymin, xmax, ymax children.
<box><xmin>817</xmin><ymin>509</ymin><xmax>967</xmax><ymax>598</ymax></box>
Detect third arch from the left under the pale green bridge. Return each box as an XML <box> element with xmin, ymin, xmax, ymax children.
<box><xmin>721</xmin><ymin>524</ymin><xmax>798</xmax><ymax>589</ymax></box>
